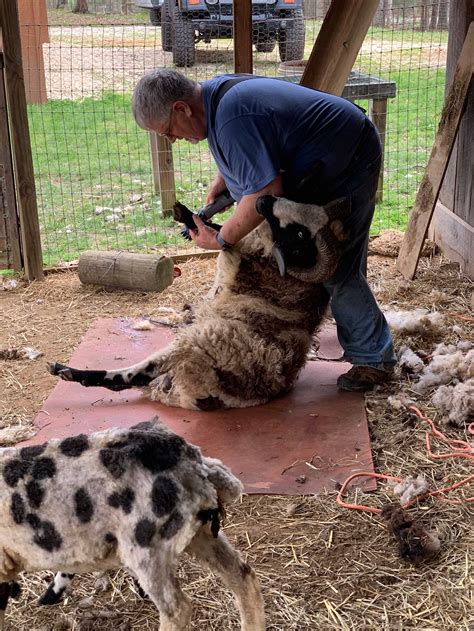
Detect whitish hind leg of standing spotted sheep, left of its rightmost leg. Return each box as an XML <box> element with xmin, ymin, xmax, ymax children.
<box><xmin>130</xmin><ymin>564</ymin><xmax>191</xmax><ymax>631</ymax></box>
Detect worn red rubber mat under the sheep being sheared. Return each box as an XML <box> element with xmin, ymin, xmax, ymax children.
<box><xmin>24</xmin><ymin>319</ymin><xmax>375</xmax><ymax>495</ymax></box>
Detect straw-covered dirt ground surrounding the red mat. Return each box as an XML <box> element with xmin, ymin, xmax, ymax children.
<box><xmin>0</xmin><ymin>256</ymin><xmax>474</xmax><ymax>631</ymax></box>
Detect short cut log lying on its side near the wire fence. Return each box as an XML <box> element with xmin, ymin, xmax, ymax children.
<box><xmin>77</xmin><ymin>250</ymin><xmax>174</xmax><ymax>291</ymax></box>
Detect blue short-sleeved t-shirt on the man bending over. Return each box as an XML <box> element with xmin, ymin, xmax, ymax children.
<box><xmin>201</xmin><ymin>75</ymin><xmax>365</xmax><ymax>201</ymax></box>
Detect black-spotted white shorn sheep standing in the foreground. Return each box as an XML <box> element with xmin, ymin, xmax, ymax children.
<box><xmin>0</xmin><ymin>418</ymin><xmax>264</xmax><ymax>631</ymax></box>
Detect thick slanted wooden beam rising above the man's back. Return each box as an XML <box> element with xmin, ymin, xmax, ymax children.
<box><xmin>300</xmin><ymin>0</ymin><xmax>379</xmax><ymax>96</ymax></box>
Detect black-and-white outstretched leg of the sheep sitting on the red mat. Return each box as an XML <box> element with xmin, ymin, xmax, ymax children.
<box><xmin>48</xmin><ymin>346</ymin><xmax>174</xmax><ymax>391</ymax></box>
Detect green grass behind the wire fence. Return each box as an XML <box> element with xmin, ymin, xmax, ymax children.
<box><xmin>29</xmin><ymin>68</ymin><xmax>444</xmax><ymax>265</ymax></box>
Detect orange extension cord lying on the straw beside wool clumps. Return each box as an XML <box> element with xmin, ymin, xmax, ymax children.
<box><xmin>336</xmin><ymin>405</ymin><xmax>474</xmax><ymax>514</ymax></box>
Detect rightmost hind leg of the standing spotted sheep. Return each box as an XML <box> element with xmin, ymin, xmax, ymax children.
<box><xmin>186</xmin><ymin>528</ymin><xmax>265</xmax><ymax>631</ymax></box>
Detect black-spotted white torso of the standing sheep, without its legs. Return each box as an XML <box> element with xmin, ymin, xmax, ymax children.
<box><xmin>0</xmin><ymin>424</ymin><xmax>225</xmax><ymax>582</ymax></box>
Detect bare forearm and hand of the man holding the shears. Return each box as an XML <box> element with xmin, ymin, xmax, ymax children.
<box><xmin>190</xmin><ymin>175</ymin><xmax>283</xmax><ymax>250</ymax></box>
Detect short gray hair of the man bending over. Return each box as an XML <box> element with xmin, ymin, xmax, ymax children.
<box><xmin>132</xmin><ymin>68</ymin><xmax>198</xmax><ymax>129</ymax></box>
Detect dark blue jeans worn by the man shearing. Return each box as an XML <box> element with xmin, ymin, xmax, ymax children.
<box><xmin>322</xmin><ymin>119</ymin><xmax>396</xmax><ymax>369</ymax></box>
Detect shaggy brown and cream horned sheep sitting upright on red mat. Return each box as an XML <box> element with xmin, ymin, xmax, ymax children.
<box><xmin>49</xmin><ymin>196</ymin><xmax>350</xmax><ymax>410</ymax></box>
